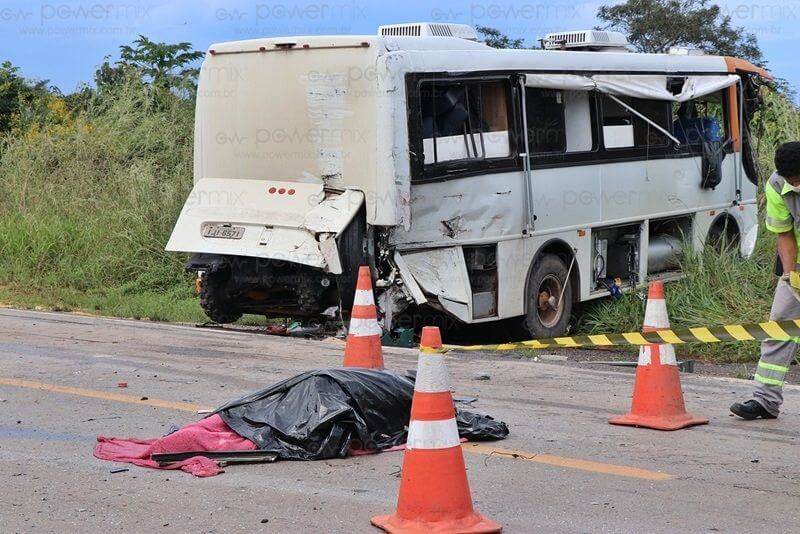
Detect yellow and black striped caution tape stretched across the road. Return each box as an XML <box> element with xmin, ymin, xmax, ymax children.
<box><xmin>445</xmin><ymin>320</ymin><xmax>800</xmax><ymax>351</ymax></box>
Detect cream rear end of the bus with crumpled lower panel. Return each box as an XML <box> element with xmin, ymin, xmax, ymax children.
<box><xmin>167</xmin><ymin>37</ymin><xmax>393</xmax><ymax>323</ymax></box>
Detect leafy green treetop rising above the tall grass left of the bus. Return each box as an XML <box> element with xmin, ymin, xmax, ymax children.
<box><xmin>95</xmin><ymin>35</ymin><xmax>203</xmax><ymax>91</ymax></box>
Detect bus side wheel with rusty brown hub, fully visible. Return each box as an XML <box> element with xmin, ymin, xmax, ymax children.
<box><xmin>523</xmin><ymin>254</ymin><xmax>572</xmax><ymax>339</ymax></box>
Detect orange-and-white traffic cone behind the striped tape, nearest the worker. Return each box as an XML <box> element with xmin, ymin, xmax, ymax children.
<box><xmin>608</xmin><ymin>282</ymin><xmax>708</xmax><ymax>430</ymax></box>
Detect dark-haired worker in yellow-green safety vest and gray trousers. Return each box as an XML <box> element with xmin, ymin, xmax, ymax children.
<box><xmin>731</xmin><ymin>141</ymin><xmax>800</xmax><ymax>419</ymax></box>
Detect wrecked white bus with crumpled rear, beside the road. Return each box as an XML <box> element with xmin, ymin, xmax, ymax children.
<box><xmin>167</xmin><ymin>23</ymin><xmax>770</xmax><ymax>337</ymax></box>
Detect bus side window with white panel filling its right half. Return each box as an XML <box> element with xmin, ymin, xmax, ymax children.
<box><xmin>525</xmin><ymin>88</ymin><xmax>596</xmax><ymax>154</ymax></box>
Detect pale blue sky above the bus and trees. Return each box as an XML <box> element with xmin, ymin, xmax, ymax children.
<box><xmin>0</xmin><ymin>0</ymin><xmax>800</xmax><ymax>93</ymax></box>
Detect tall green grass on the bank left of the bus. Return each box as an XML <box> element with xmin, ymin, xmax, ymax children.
<box><xmin>0</xmin><ymin>78</ymin><xmax>193</xmax><ymax>302</ymax></box>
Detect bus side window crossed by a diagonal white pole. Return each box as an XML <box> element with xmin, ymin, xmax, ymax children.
<box><xmin>602</xmin><ymin>95</ymin><xmax>672</xmax><ymax>149</ymax></box>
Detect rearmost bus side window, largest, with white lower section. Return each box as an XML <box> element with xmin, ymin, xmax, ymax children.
<box><xmin>419</xmin><ymin>81</ymin><xmax>510</xmax><ymax>165</ymax></box>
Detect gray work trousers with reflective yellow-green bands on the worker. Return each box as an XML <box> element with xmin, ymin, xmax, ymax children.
<box><xmin>753</xmin><ymin>280</ymin><xmax>800</xmax><ymax>415</ymax></box>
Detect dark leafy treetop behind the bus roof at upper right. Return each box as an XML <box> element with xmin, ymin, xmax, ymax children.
<box><xmin>597</xmin><ymin>0</ymin><xmax>765</xmax><ymax>66</ymax></box>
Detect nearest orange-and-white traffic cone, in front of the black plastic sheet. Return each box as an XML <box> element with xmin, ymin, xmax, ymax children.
<box><xmin>372</xmin><ymin>326</ymin><xmax>503</xmax><ymax>534</ymax></box>
